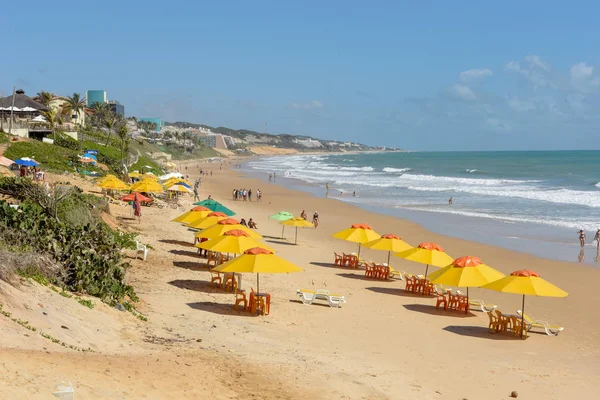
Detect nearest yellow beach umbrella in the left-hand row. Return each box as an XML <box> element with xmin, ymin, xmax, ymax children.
<box><xmin>213</xmin><ymin>247</ymin><xmax>303</xmax><ymax>306</ymax></box>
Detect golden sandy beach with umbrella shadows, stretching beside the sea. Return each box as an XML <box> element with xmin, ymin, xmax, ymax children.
<box><xmin>0</xmin><ymin>161</ymin><xmax>600</xmax><ymax>399</ymax></box>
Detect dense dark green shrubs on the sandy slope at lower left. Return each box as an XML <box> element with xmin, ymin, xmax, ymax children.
<box><xmin>0</xmin><ymin>178</ymin><xmax>137</xmax><ymax>304</ymax></box>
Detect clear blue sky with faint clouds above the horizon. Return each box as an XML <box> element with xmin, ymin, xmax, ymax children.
<box><xmin>0</xmin><ymin>0</ymin><xmax>600</xmax><ymax>150</ymax></box>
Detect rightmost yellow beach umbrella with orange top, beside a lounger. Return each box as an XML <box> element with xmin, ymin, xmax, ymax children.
<box><xmin>482</xmin><ymin>269</ymin><xmax>569</xmax><ymax>337</ymax></box>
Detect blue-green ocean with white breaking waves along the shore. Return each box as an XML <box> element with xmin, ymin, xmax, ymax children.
<box><xmin>247</xmin><ymin>151</ymin><xmax>600</xmax><ymax>262</ymax></box>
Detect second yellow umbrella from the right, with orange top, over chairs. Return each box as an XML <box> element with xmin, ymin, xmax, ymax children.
<box><xmin>427</xmin><ymin>256</ymin><xmax>504</xmax><ymax>313</ymax></box>
